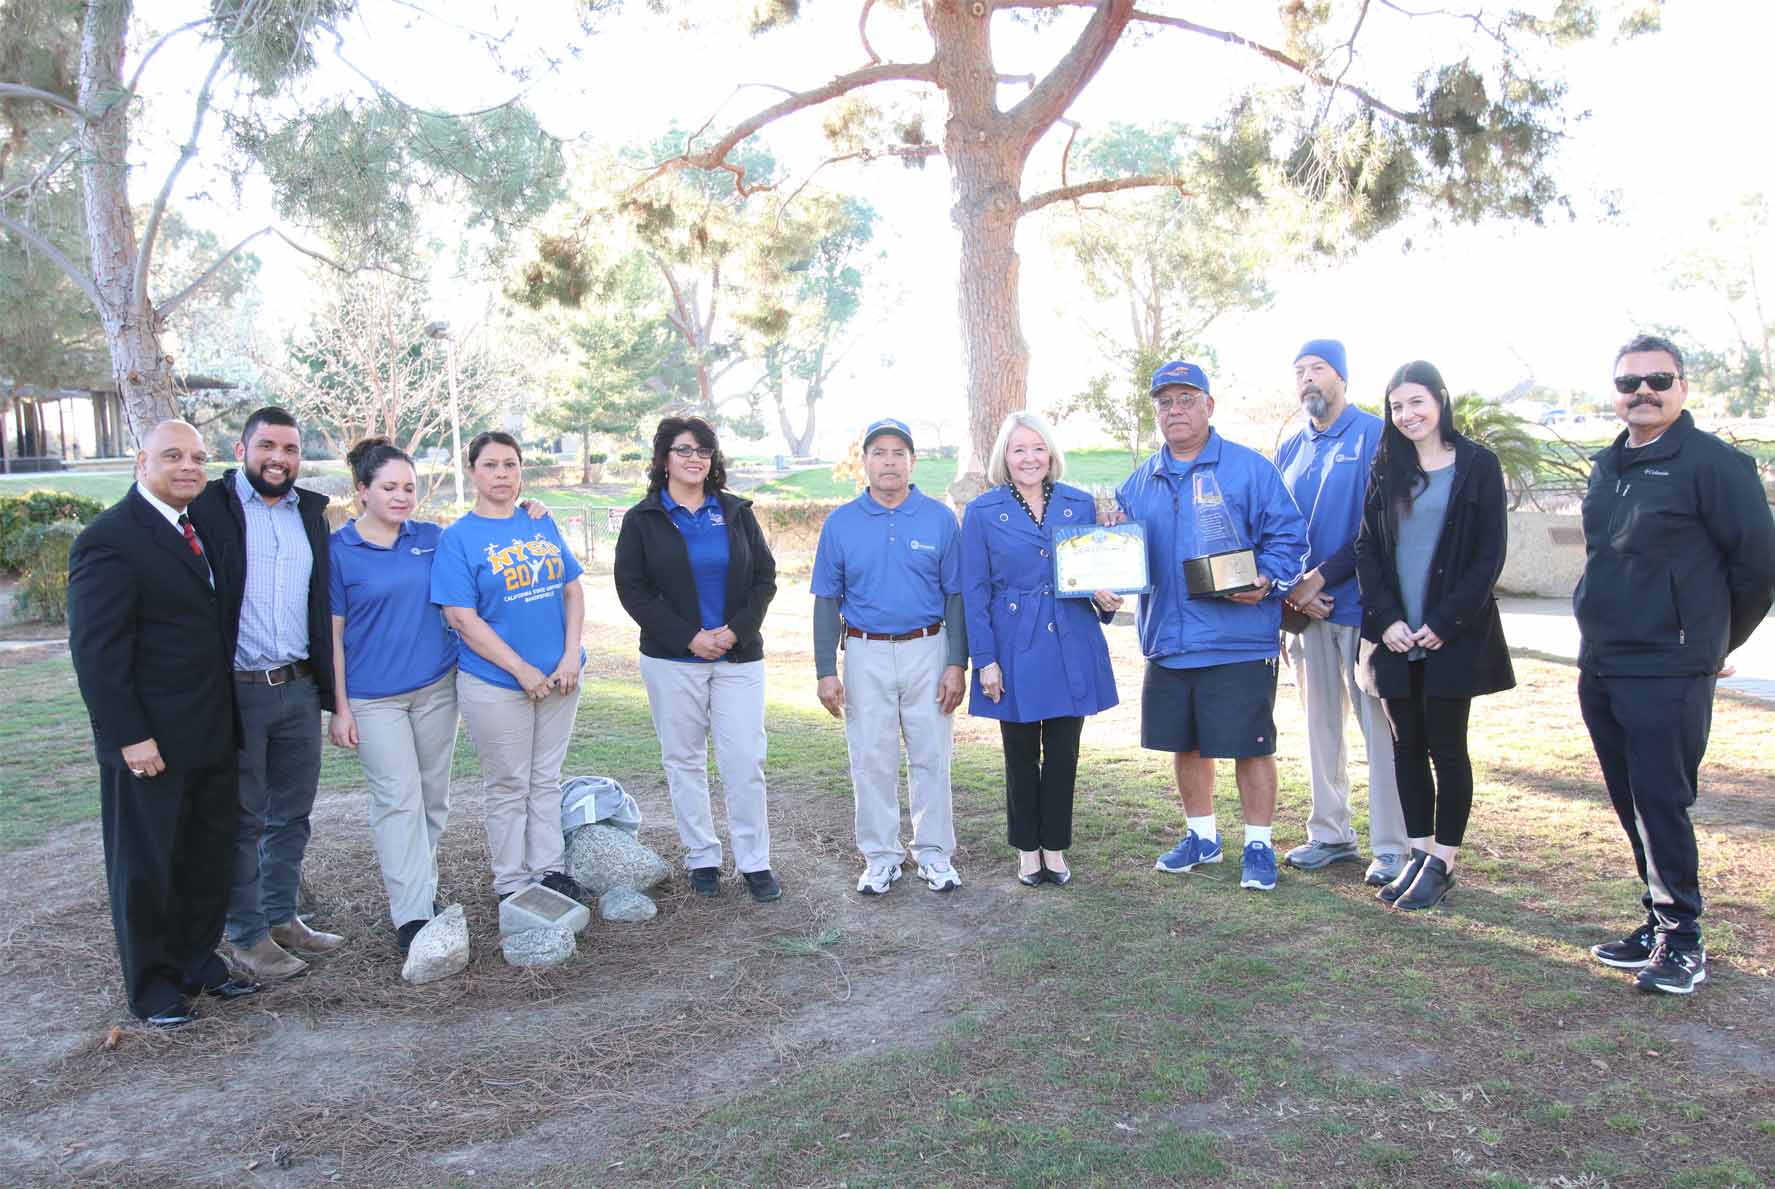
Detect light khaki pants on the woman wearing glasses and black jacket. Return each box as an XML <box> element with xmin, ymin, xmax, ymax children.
<box><xmin>641</xmin><ymin>657</ymin><xmax>770</xmax><ymax>871</ymax></box>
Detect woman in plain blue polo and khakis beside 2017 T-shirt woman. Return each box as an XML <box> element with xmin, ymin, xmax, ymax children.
<box><xmin>328</xmin><ymin>438</ymin><xmax>456</xmax><ymax>953</ymax></box>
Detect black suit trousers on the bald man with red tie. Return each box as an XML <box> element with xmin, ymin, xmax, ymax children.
<box><xmin>99</xmin><ymin>758</ymin><xmax>240</xmax><ymax>1019</ymax></box>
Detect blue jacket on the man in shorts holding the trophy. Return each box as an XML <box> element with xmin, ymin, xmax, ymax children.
<box><xmin>1115</xmin><ymin>428</ymin><xmax>1306</xmax><ymax>669</ymax></box>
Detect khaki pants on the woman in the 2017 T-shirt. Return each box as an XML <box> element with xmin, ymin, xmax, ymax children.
<box><xmin>456</xmin><ymin>673</ymin><xmax>579</xmax><ymax>896</ymax></box>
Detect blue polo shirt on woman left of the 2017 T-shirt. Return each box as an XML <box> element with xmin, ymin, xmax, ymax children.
<box><xmin>328</xmin><ymin>520</ymin><xmax>456</xmax><ymax>697</ymax></box>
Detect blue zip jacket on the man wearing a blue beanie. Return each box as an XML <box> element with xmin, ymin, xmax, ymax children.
<box><xmin>1276</xmin><ymin>405</ymin><xmax>1383</xmax><ymax>628</ymax></box>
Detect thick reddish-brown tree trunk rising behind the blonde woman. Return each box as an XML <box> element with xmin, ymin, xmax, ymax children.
<box><xmin>925</xmin><ymin>0</ymin><xmax>1030</xmax><ymax>506</ymax></box>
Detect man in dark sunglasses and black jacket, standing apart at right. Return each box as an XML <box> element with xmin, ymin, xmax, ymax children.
<box><xmin>1573</xmin><ymin>334</ymin><xmax>1775</xmax><ymax>996</ymax></box>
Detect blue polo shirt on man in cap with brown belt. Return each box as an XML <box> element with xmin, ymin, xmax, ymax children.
<box><xmin>811</xmin><ymin>484</ymin><xmax>962</xmax><ymax>635</ymax></box>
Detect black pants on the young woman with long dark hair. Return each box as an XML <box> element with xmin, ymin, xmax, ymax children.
<box><xmin>1386</xmin><ymin>660</ymin><xmax>1473</xmax><ymax>846</ymax></box>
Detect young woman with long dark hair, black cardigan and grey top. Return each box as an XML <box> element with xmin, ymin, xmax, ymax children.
<box><xmin>1356</xmin><ymin>360</ymin><xmax>1516</xmax><ymax>910</ymax></box>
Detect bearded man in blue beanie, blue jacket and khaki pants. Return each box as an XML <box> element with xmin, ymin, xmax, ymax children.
<box><xmin>1276</xmin><ymin>339</ymin><xmax>1409</xmax><ymax>886</ymax></box>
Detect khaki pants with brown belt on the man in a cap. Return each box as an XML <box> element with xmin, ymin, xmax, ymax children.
<box><xmin>845</xmin><ymin>632</ymin><xmax>955</xmax><ymax>862</ymax></box>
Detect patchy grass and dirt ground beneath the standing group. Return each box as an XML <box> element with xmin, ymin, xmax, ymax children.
<box><xmin>0</xmin><ymin>596</ymin><xmax>1775</xmax><ymax>1187</ymax></box>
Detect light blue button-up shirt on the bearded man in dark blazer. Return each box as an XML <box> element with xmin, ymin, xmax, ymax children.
<box><xmin>234</xmin><ymin>470</ymin><xmax>314</xmax><ymax>669</ymax></box>
